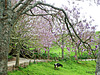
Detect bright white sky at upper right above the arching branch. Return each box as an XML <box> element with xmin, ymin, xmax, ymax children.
<box><xmin>46</xmin><ymin>0</ymin><xmax>100</xmax><ymax>31</ymax></box>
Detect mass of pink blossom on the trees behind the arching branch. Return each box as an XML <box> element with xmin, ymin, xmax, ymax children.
<box><xmin>9</xmin><ymin>1</ymin><xmax>98</xmax><ymax>60</ymax></box>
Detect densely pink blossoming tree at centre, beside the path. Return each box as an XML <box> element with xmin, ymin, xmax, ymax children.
<box><xmin>33</xmin><ymin>17</ymin><xmax>55</xmax><ymax>58</ymax></box>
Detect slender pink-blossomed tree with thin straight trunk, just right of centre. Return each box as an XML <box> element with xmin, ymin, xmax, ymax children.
<box><xmin>53</xmin><ymin>20</ymin><xmax>68</xmax><ymax>59</ymax></box>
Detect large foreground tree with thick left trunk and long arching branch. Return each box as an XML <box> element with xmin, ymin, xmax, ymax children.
<box><xmin>0</xmin><ymin>0</ymin><xmax>99</xmax><ymax>75</ymax></box>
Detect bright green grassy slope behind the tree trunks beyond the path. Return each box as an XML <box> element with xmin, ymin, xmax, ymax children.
<box><xmin>31</xmin><ymin>46</ymin><xmax>97</xmax><ymax>59</ymax></box>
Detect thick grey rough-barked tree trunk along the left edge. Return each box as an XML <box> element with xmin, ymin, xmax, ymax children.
<box><xmin>0</xmin><ymin>0</ymin><xmax>12</xmax><ymax>75</ymax></box>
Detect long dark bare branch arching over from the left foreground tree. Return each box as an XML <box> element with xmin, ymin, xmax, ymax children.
<box><xmin>15</xmin><ymin>1</ymin><xmax>94</xmax><ymax>58</ymax></box>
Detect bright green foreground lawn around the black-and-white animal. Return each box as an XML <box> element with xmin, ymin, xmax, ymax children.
<box><xmin>8</xmin><ymin>61</ymin><xmax>96</xmax><ymax>75</ymax></box>
